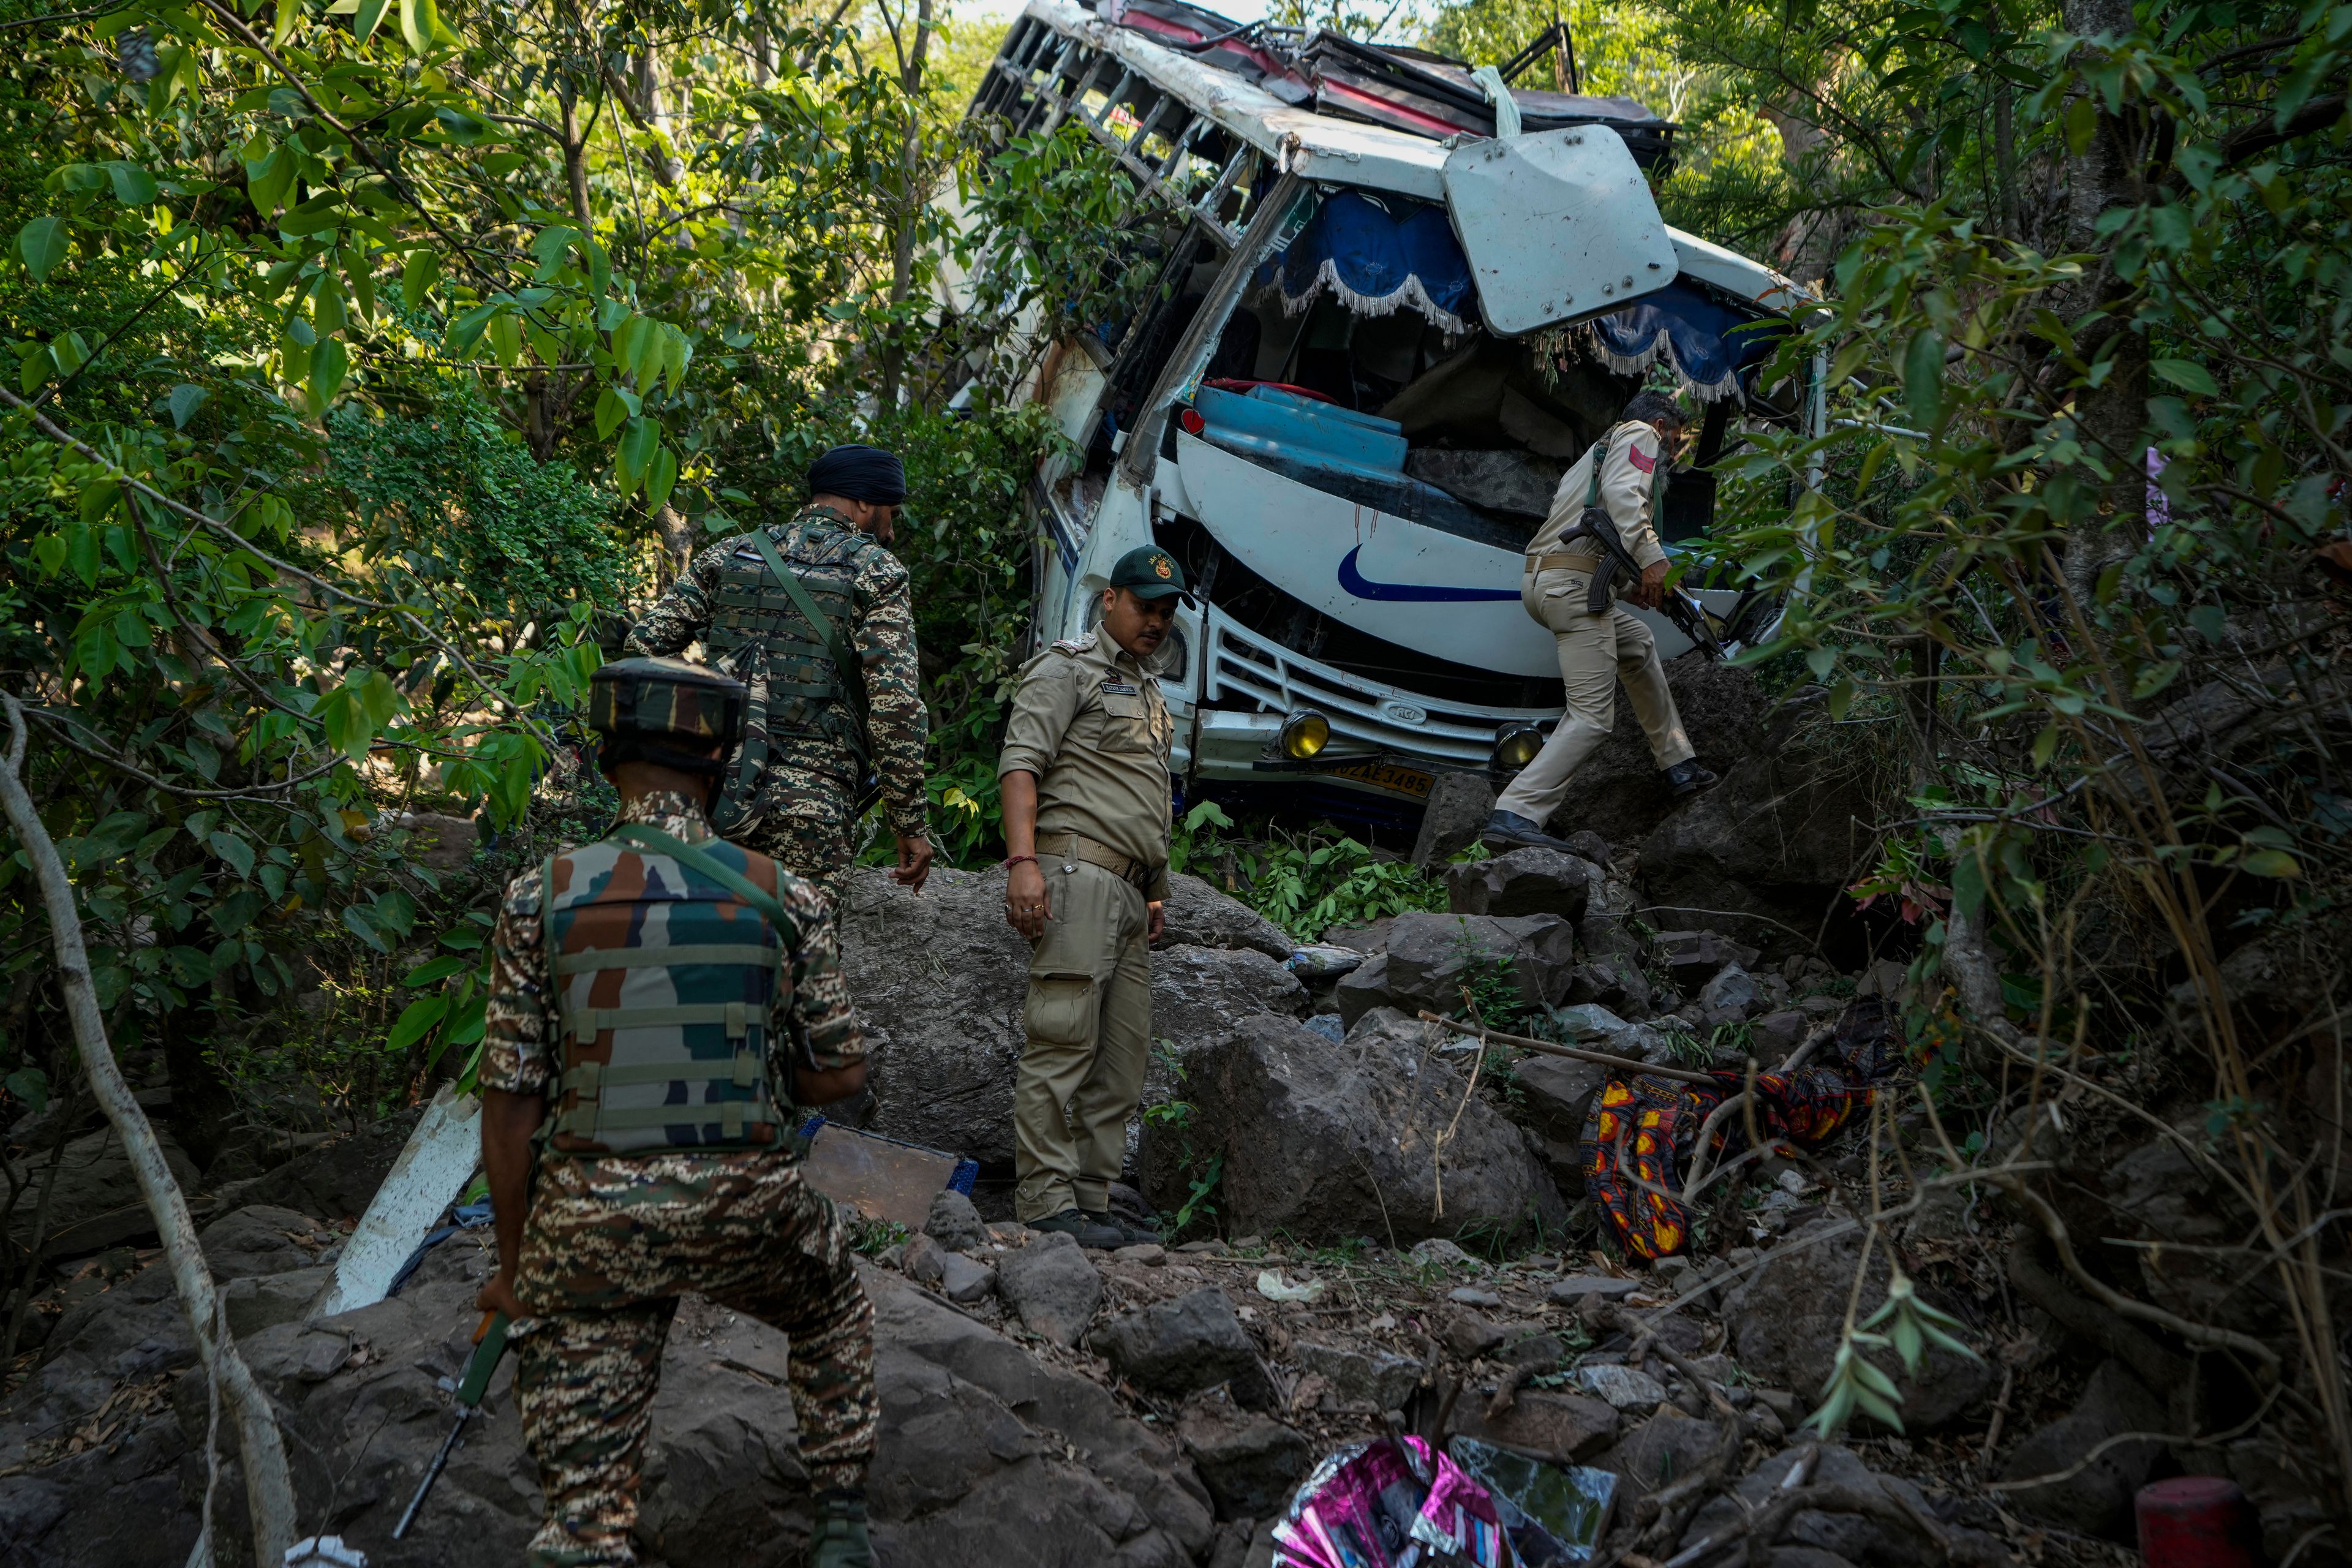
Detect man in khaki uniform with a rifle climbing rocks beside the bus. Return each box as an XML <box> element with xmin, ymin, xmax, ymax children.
<box><xmin>1479</xmin><ymin>393</ymin><xmax>1717</xmax><ymax>853</ymax></box>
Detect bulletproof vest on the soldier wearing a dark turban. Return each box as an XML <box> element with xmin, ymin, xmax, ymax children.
<box><xmin>703</xmin><ymin>524</ymin><xmax>868</xmax><ymax>830</ymax></box>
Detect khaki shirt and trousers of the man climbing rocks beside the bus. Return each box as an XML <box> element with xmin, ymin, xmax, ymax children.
<box><xmin>1493</xmin><ymin>421</ymin><xmax>1698</xmax><ymax>823</ymax></box>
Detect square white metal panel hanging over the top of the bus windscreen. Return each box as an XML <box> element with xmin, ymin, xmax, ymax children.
<box><xmin>1444</xmin><ymin>124</ymin><xmax>1682</xmax><ymax>336</ymax></box>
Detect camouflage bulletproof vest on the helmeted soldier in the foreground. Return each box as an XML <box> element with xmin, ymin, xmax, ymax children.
<box><xmin>541</xmin><ymin>839</ymin><xmax>797</xmax><ymax>1154</ymax></box>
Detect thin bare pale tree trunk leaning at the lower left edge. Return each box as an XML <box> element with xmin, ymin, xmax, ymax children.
<box><xmin>0</xmin><ymin>696</ymin><xmax>296</xmax><ymax>1563</ymax></box>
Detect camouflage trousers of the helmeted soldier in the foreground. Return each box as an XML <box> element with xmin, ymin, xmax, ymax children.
<box><xmin>515</xmin><ymin>1152</ymin><xmax>880</xmax><ymax>1568</ymax></box>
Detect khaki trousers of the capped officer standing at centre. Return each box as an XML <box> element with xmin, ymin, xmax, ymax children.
<box><xmin>1014</xmin><ymin>856</ymin><xmax>1153</xmax><ymax>1220</ymax></box>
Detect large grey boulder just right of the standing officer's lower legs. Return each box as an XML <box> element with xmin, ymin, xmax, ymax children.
<box><xmin>1140</xmin><ymin>1013</ymin><xmax>1566</xmax><ymax>1246</ymax></box>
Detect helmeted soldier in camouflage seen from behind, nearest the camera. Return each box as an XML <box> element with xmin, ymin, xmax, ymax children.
<box><xmin>480</xmin><ymin>658</ymin><xmax>877</xmax><ymax>1568</ymax></box>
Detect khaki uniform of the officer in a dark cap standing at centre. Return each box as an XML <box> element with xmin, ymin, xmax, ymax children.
<box><xmin>997</xmin><ymin>630</ymin><xmax>1176</xmax><ymax>1223</ymax></box>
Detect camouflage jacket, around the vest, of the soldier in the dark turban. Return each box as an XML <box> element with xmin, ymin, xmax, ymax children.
<box><xmin>628</xmin><ymin>505</ymin><xmax>929</xmax><ymax>837</ymax></box>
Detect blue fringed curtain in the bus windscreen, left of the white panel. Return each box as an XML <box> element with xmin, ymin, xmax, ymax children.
<box><xmin>1256</xmin><ymin>190</ymin><xmax>1470</xmax><ymax>331</ymax></box>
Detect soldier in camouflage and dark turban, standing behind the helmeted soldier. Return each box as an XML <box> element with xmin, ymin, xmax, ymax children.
<box><xmin>628</xmin><ymin>447</ymin><xmax>932</xmax><ymax>910</ymax></box>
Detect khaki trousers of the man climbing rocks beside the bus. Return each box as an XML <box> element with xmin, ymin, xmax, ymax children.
<box><xmin>1493</xmin><ymin>569</ymin><xmax>1698</xmax><ymax>823</ymax></box>
